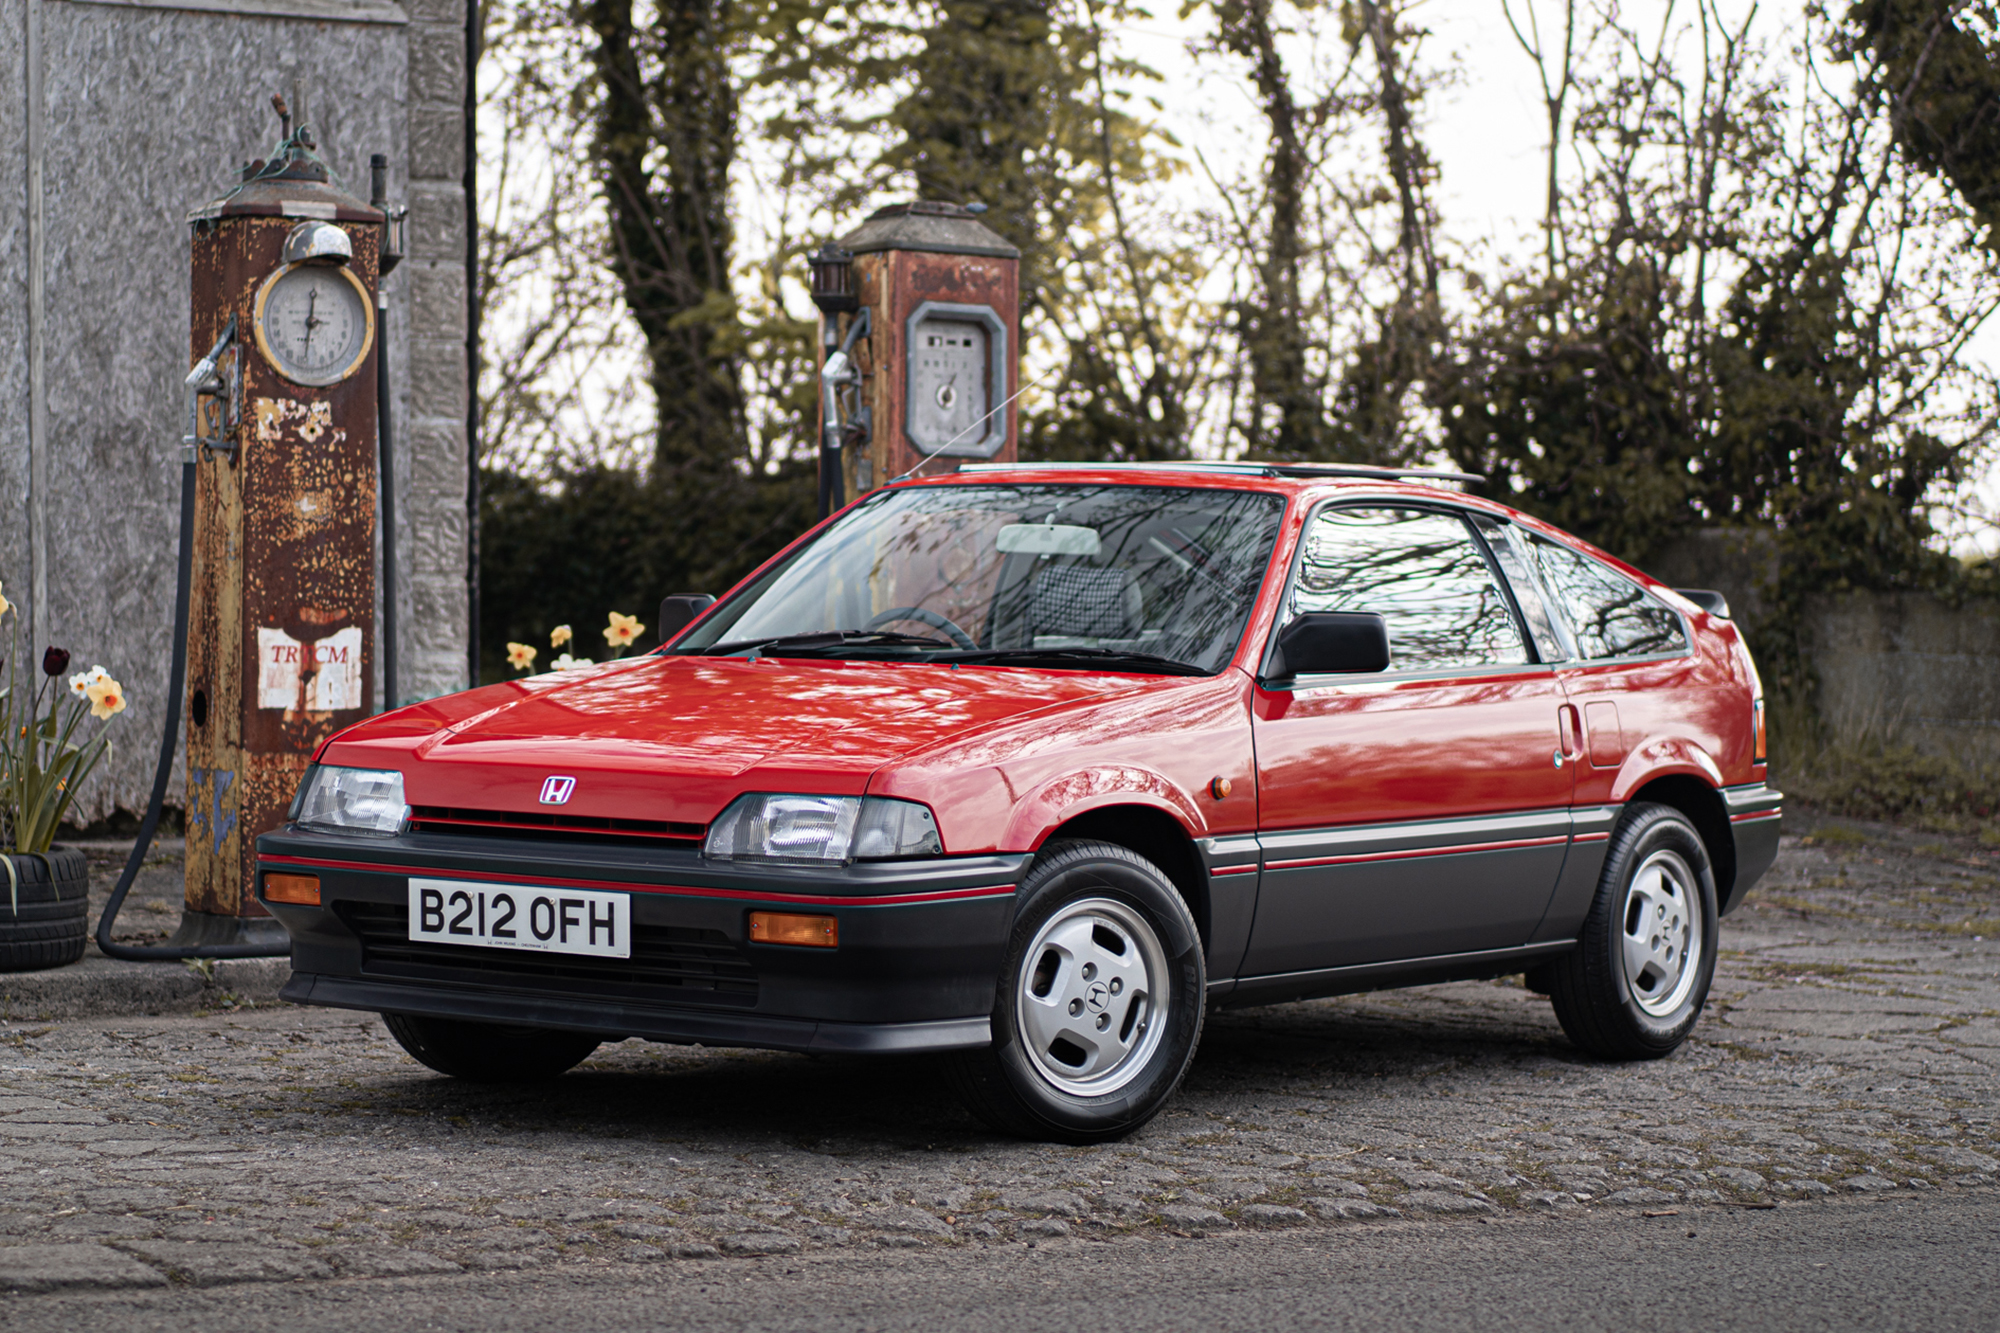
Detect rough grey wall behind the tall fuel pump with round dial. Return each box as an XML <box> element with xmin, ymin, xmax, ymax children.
<box><xmin>0</xmin><ymin>0</ymin><xmax>468</xmax><ymax>819</ymax></box>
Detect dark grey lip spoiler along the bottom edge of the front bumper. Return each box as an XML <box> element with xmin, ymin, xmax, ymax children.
<box><xmin>278</xmin><ymin>973</ymin><xmax>992</xmax><ymax>1055</ymax></box>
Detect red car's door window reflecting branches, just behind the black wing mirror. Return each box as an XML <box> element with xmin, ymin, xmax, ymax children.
<box><xmin>1290</xmin><ymin>508</ymin><xmax>1528</xmax><ymax>671</ymax></box>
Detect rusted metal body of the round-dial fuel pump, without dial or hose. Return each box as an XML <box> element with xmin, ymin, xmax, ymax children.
<box><xmin>186</xmin><ymin>202</ymin><xmax>380</xmax><ymax>917</ymax></box>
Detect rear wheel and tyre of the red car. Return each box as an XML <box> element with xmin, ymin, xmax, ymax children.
<box><xmin>1546</xmin><ymin>803</ymin><xmax>1720</xmax><ymax>1061</ymax></box>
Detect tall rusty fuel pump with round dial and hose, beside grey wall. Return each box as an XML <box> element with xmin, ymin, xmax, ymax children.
<box><xmin>96</xmin><ymin>98</ymin><xmax>402</xmax><ymax>959</ymax></box>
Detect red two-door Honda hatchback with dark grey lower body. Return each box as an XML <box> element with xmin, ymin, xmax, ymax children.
<box><xmin>258</xmin><ymin>462</ymin><xmax>1780</xmax><ymax>1141</ymax></box>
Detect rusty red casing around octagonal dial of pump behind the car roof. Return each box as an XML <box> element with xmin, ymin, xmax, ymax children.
<box><xmin>824</xmin><ymin>222</ymin><xmax>1020</xmax><ymax>498</ymax></box>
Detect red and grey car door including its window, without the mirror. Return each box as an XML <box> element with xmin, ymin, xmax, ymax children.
<box><xmin>1240</xmin><ymin>502</ymin><xmax>1574</xmax><ymax>977</ymax></box>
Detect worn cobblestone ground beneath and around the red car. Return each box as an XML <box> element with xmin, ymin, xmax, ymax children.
<box><xmin>0</xmin><ymin>819</ymin><xmax>2000</xmax><ymax>1288</ymax></box>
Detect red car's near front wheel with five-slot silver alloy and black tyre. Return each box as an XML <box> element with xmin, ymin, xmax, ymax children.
<box><xmin>946</xmin><ymin>843</ymin><xmax>1208</xmax><ymax>1143</ymax></box>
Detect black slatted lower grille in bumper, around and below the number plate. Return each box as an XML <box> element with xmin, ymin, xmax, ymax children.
<box><xmin>334</xmin><ymin>903</ymin><xmax>756</xmax><ymax>1005</ymax></box>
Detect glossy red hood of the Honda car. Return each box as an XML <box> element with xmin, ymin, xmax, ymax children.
<box><xmin>320</xmin><ymin>656</ymin><xmax>1144</xmax><ymax>825</ymax></box>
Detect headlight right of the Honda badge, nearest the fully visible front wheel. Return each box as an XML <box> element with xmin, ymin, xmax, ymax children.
<box><xmin>702</xmin><ymin>793</ymin><xmax>944</xmax><ymax>865</ymax></box>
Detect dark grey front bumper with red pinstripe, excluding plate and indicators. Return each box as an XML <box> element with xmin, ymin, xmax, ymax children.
<box><xmin>258</xmin><ymin>827</ymin><xmax>1028</xmax><ymax>1051</ymax></box>
